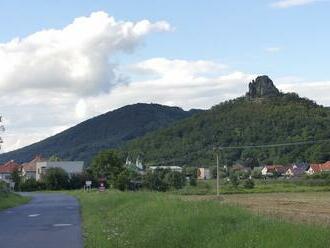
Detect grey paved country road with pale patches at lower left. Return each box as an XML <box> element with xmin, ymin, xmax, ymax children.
<box><xmin>0</xmin><ymin>193</ymin><xmax>83</xmax><ymax>248</ymax></box>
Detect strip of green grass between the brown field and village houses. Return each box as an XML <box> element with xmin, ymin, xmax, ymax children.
<box><xmin>177</xmin><ymin>180</ymin><xmax>330</xmax><ymax>195</ymax></box>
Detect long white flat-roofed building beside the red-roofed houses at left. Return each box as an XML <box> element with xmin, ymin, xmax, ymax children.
<box><xmin>36</xmin><ymin>161</ymin><xmax>84</xmax><ymax>181</ymax></box>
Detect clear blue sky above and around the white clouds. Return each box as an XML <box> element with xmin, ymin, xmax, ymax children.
<box><xmin>0</xmin><ymin>0</ymin><xmax>330</xmax><ymax>80</ymax></box>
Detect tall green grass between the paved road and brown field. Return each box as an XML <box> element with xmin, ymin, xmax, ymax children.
<box><xmin>72</xmin><ymin>191</ymin><xmax>330</xmax><ymax>248</ymax></box>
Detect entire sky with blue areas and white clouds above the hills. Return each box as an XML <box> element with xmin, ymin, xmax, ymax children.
<box><xmin>0</xmin><ymin>0</ymin><xmax>330</xmax><ymax>152</ymax></box>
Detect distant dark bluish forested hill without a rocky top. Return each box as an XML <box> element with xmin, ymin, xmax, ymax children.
<box><xmin>0</xmin><ymin>103</ymin><xmax>200</xmax><ymax>163</ymax></box>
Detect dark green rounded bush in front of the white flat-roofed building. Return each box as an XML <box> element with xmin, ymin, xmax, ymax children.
<box><xmin>42</xmin><ymin>168</ymin><xmax>69</xmax><ymax>190</ymax></box>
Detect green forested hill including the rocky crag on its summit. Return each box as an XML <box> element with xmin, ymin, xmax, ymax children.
<box><xmin>123</xmin><ymin>76</ymin><xmax>330</xmax><ymax>166</ymax></box>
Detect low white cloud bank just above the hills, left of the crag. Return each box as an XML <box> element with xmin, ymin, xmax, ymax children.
<box><xmin>82</xmin><ymin>58</ymin><xmax>254</xmax><ymax>114</ymax></box>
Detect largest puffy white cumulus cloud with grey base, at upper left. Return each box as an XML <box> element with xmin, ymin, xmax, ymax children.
<box><xmin>0</xmin><ymin>12</ymin><xmax>171</xmax><ymax>95</ymax></box>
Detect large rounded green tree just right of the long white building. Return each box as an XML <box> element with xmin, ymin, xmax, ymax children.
<box><xmin>91</xmin><ymin>150</ymin><xmax>124</xmax><ymax>183</ymax></box>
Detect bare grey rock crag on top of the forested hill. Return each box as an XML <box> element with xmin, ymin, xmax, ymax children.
<box><xmin>246</xmin><ymin>76</ymin><xmax>281</xmax><ymax>98</ymax></box>
